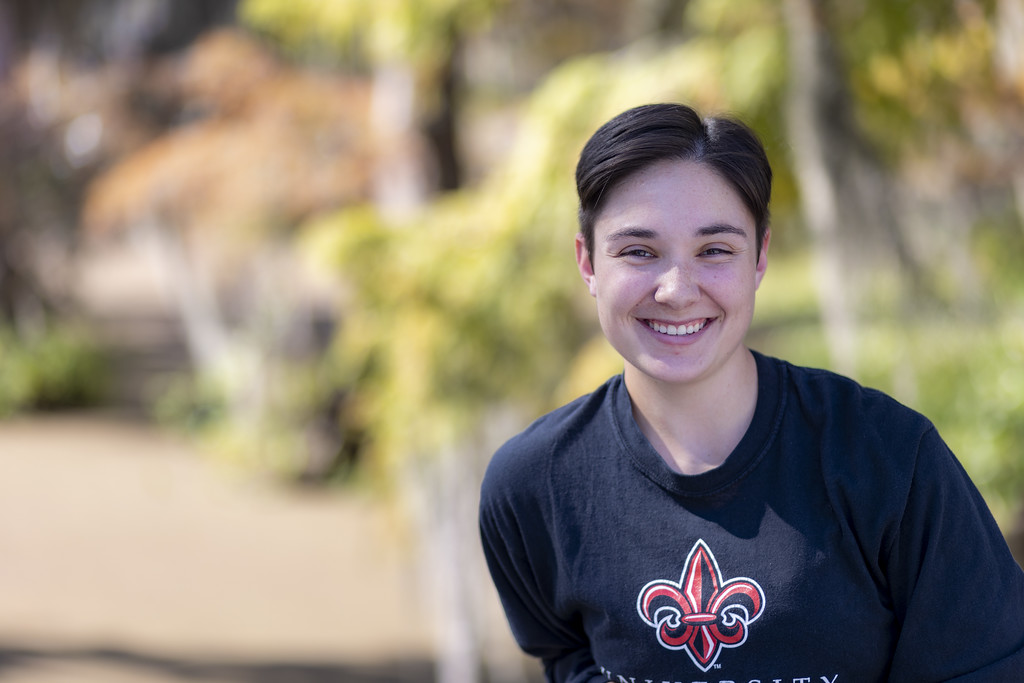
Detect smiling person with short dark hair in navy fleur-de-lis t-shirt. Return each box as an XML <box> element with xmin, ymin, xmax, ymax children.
<box><xmin>480</xmin><ymin>104</ymin><xmax>1024</xmax><ymax>683</ymax></box>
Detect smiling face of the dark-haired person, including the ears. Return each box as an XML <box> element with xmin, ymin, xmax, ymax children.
<box><xmin>577</xmin><ymin>161</ymin><xmax>768</xmax><ymax>393</ymax></box>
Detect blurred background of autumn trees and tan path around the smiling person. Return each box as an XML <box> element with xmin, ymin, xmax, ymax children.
<box><xmin>0</xmin><ymin>0</ymin><xmax>1024</xmax><ymax>683</ymax></box>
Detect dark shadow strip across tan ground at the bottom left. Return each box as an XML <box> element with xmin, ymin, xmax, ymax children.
<box><xmin>0</xmin><ymin>645</ymin><xmax>434</xmax><ymax>683</ymax></box>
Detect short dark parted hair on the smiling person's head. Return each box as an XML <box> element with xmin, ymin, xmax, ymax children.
<box><xmin>575</xmin><ymin>103</ymin><xmax>771</xmax><ymax>257</ymax></box>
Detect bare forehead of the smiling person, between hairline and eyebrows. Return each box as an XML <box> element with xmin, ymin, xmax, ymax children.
<box><xmin>594</xmin><ymin>160</ymin><xmax>755</xmax><ymax>239</ymax></box>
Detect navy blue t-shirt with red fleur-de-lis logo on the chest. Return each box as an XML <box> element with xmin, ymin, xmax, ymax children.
<box><xmin>480</xmin><ymin>354</ymin><xmax>1024</xmax><ymax>683</ymax></box>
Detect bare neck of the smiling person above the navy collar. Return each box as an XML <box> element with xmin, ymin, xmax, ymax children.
<box><xmin>625</xmin><ymin>348</ymin><xmax>758</xmax><ymax>474</ymax></box>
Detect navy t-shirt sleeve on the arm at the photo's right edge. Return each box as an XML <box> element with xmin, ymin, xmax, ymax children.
<box><xmin>887</xmin><ymin>429</ymin><xmax>1024</xmax><ymax>683</ymax></box>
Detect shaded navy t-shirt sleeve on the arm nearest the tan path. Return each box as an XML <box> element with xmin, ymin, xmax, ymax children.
<box><xmin>480</xmin><ymin>464</ymin><xmax>607</xmax><ymax>683</ymax></box>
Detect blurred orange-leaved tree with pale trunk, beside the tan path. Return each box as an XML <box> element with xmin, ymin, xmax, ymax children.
<box><xmin>83</xmin><ymin>30</ymin><xmax>374</xmax><ymax>478</ymax></box>
